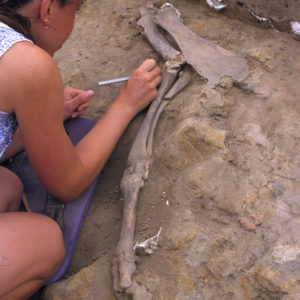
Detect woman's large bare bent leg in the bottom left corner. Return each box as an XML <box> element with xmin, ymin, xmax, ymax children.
<box><xmin>0</xmin><ymin>212</ymin><xmax>65</xmax><ymax>300</ymax></box>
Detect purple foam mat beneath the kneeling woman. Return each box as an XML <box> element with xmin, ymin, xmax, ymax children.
<box><xmin>17</xmin><ymin>118</ymin><xmax>99</xmax><ymax>285</ymax></box>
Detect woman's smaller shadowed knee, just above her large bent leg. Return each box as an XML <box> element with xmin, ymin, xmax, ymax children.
<box><xmin>0</xmin><ymin>166</ymin><xmax>23</xmax><ymax>212</ymax></box>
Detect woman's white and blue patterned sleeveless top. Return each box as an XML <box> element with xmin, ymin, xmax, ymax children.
<box><xmin>0</xmin><ymin>22</ymin><xmax>32</xmax><ymax>159</ymax></box>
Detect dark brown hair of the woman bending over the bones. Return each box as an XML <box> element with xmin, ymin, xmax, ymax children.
<box><xmin>0</xmin><ymin>0</ymin><xmax>69</xmax><ymax>40</ymax></box>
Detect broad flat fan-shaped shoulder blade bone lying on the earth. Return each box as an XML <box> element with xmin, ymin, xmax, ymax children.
<box><xmin>154</xmin><ymin>4</ymin><xmax>249</xmax><ymax>88</ymax></box>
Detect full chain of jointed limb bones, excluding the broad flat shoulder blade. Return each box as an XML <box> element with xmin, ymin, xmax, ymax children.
<box><xmin>112</xmin><ymin>4</ymin><xmax>188</xmax><ymax>300</ymax></box>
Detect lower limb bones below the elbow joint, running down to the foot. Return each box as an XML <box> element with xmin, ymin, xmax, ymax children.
<box><xmin>113</xmin><ymin>65</ymin><xmax>183</xmax><ymax>300</ymax></box>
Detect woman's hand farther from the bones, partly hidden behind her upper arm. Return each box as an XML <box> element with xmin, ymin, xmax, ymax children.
<box><xmin>64</xmin><ymin>86</ymin><xmax>94</xmax><ymax>120</ymax></box>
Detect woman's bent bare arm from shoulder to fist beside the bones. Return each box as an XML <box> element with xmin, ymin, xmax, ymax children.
<box><xmin>2</xmin><ymin>44</ymin><xmax>161</xmax><ymax>200</ymax></box>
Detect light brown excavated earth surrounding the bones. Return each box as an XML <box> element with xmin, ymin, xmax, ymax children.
<box><xmin>43</xmin><ymin>0</ymin><xmax>300</xmax><ymax>300</ymax></box>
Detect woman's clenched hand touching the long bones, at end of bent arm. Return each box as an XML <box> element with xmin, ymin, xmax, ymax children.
<box><xmin>116</xmin><ymin>59</ymin><xmax>161</xmax><ymax>116</ymax></box>
